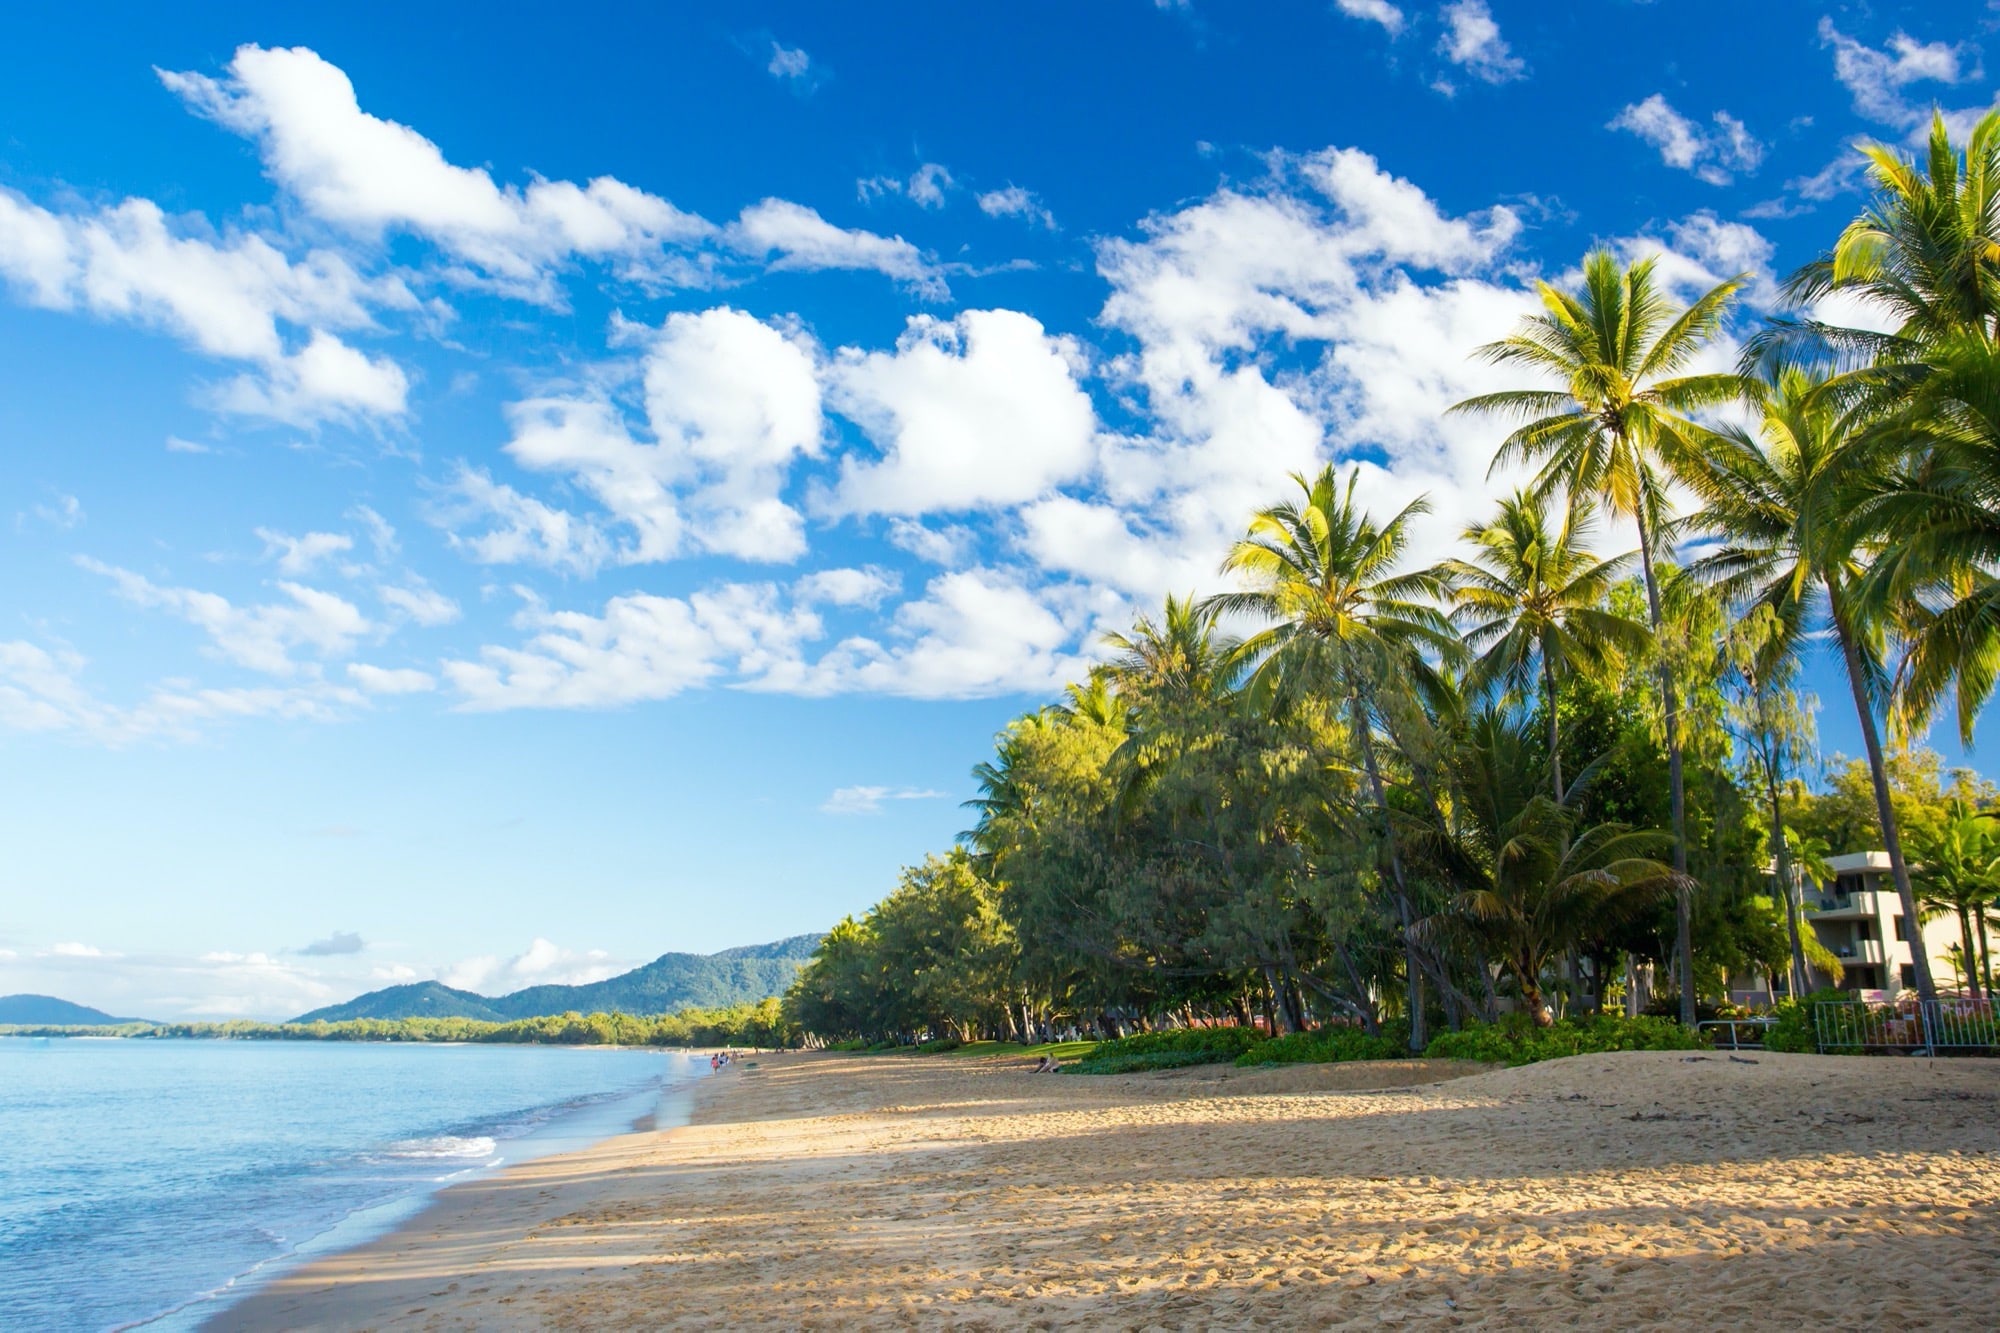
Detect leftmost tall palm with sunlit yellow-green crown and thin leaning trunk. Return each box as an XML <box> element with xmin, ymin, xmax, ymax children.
<box><xmin>1202</xmin><ymin>466</ymin><xmax>1458</xmax><ymax>1051</ymax></box>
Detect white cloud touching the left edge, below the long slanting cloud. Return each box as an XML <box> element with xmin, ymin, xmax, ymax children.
<box><xmin>0</xmin><ymin>190</ymin><xmax>416</xmax><ymax>424</ymax></box>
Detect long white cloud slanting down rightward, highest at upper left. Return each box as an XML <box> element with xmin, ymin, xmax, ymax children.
<box><xmin>160</xmin><ymin>46</ymin><xmax>712</xmax><ymax>300</ymax></box>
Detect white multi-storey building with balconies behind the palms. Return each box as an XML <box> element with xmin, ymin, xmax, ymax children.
<box><xmin>1804</xmin><ymin>853</ymin><xmax>1962</xmax><ymax>999</ymax></box>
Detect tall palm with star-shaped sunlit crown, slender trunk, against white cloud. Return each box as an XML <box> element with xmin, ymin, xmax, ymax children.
<box><xmin>1450</xmin><ymin>250</ymin><xmax>1748</xmax><ymax>1027</ymax></box>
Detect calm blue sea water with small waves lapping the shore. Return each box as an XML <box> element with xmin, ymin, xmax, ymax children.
<box><xmin>0</xmin><ymin>1037</ymin><xmax>708</xmax><ymax>1329</ymax></box>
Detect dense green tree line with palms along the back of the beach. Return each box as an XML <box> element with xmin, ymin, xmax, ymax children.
<box><xmin>786</xmin><ymin>114</ymin><xmax>2000</xmax><ymax>1049</ymax></box>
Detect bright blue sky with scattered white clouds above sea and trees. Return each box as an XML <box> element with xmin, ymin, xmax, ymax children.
<box><xmin>0</xmin><ymin>0</ymin><xmax>2000</xmax><ymax>1019</ymax></box>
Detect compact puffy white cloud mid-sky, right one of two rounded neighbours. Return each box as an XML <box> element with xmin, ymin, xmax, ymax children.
<box><xmin>826</xmin><ymin>310</ymin><xmax>1096</xmax><ymax>514</ymax></box>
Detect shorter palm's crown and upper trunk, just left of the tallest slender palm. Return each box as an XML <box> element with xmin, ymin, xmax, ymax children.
<box><xmin>1438</xmin><ymin>490</ymin><xmax>1650</xmax><ymax>801</ymax></box>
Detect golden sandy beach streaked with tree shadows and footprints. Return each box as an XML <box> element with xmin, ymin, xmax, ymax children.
<box><xmin>214</xmin><ymin>1053</ymin><xmax>2000</xmax><ymax>1329</ymax></box>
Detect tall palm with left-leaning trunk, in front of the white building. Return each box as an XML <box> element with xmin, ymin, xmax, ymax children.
<box><xmin>1682</xmin><ymin>368</ymin><xmax>1936</xmax><ymax>1001</ymax></box>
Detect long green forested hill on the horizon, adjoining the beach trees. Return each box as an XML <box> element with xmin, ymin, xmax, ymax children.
<box><xmin>294</xmin><ymin>935</ymin><xmax>820</xmax><ymax>1023</ymax></box>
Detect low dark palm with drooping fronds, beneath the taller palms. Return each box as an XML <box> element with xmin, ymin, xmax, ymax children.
<box><xmin>1426</xmin><ymin>711</ymin><xmax>1674</xmax><ymax>1025</ymax></box>
